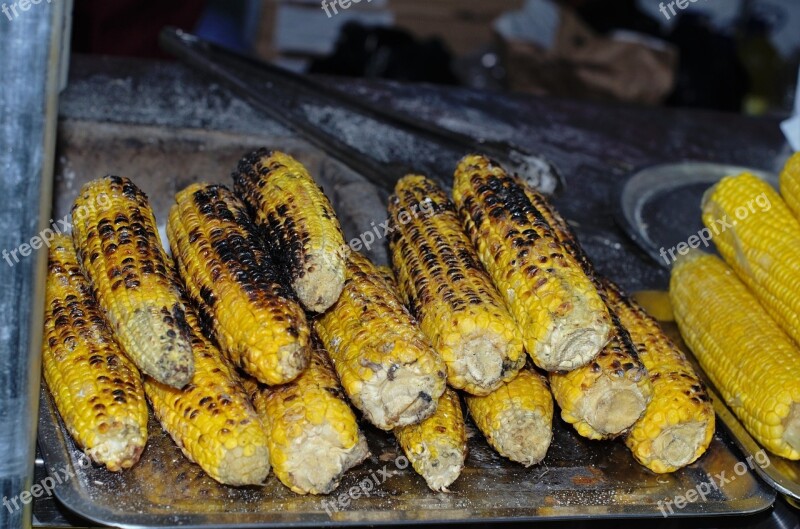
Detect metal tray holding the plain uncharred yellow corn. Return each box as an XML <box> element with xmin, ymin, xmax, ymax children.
<box><xmin>618</xmin><ymin>162</ymin><xmax>800</xmax><ymax>500</ymax></box>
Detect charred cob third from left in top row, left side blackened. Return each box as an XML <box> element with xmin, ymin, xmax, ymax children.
<box><xmin>233</xmin><ymin>149</ymin><xmax>347</xmax><ymax>312</ymax></box>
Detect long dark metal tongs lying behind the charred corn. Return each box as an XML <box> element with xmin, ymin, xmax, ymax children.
<box><xmin>160</xmin><ymin>28</ymin><xmax>562</xmax><ymax>194</ymax></box>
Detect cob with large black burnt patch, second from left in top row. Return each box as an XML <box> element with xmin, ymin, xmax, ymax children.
<box><xmin>167</xmin><ymin>184</ymin><xmax>310</xmax><ymax>384</ymax></box>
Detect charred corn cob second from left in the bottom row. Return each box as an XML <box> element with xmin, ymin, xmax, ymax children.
<box><xmin>144</xmin><ymin>303</ymin><xmax>269</xmax><ymax>486</ymax></box>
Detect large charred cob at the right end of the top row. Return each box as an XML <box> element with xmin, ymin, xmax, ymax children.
<box><xmin>453</xmin><ymin>155</ymin><xmax>611</xmax><ymax>371</ymax></box>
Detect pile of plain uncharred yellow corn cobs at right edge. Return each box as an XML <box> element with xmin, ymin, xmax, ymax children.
<box><xmin>670</xmin><ymin>154</ymin><xmax>800</xmax><ymax>460</ymax></box>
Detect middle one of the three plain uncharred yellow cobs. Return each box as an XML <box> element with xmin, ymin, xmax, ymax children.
<box><xmin>703</xmin><ymin>173</ymin><xmax>800</xmax><ymax>344</ymax></box>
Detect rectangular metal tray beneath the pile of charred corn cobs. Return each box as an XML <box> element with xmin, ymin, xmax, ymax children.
<box><xmin>39</xmin><ymin>131</ymin><xmax>775</xmax><ymax>527</ymax></box>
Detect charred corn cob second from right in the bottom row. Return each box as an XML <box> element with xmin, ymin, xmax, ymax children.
<box><xmin>523</xmin><ymin>184</ymin><xmax>653</xmax><ymax>439</ymax></box>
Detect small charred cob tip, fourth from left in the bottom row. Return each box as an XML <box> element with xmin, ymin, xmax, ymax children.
<box><xmin>394</xmin><ymin>389</ymin><xmax>467</xmax><ymax>491</ymax></box>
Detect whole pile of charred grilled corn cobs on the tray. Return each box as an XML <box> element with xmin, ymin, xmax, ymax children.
<box><xmin>44</xmin><ymin>150</ymin><xmax>714</xmax><ymax>494</ymax></box>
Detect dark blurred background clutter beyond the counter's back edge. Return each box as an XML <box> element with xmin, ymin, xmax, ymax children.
<box><xmin>72</xmin><ymin>0</ymin><xmax>800</xmax><ymax>116</ymax></box>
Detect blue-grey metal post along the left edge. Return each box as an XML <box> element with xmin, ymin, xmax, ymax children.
<box><xmin>0</xmin><ymin>2</ymin><xmax>64</xmax><ymax>528</ymax></box>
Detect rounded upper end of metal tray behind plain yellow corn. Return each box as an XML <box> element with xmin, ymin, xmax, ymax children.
<box><xmin>617</xmin><ymin>162</ymin><xmax>778</xmax><ymax>269</ymax></box>
